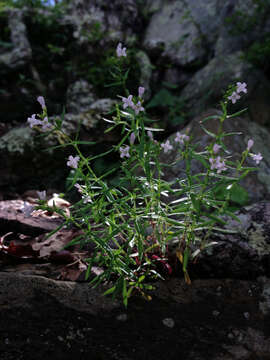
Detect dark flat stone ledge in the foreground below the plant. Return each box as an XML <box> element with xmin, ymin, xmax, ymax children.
<box><xmin>0</xmin><ymin>272</ymin><xmax>270</xmax><ymax>360</ymax></box>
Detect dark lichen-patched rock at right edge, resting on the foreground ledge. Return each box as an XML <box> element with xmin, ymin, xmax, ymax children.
<box><xmin>188</xmin><ymin>202</ymin><xmax>270</xmax><ymax>278</ymax></box>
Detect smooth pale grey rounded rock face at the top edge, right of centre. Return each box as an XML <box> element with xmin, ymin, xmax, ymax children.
<box><xmin>144</xmin><ymin>1</ymin><xmax>206</xmax><ymax>66</ymax></box>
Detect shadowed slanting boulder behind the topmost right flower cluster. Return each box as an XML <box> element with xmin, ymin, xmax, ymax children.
<box><xmin>181</xmin><ymin>51</ymin><xmax>270</xmax><ymax>125</ymax></box>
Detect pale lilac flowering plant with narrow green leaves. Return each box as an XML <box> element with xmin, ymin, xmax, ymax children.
<box><xmin>28</xmin><ymin>44</ymin><xmax>262</xmax><ymax>305</ymax></box>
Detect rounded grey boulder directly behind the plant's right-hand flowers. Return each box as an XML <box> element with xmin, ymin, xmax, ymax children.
<box><xmin>161</xmin><ymin>109</ymin><xmax>270</xmax><ymax>202</ymax></box>
